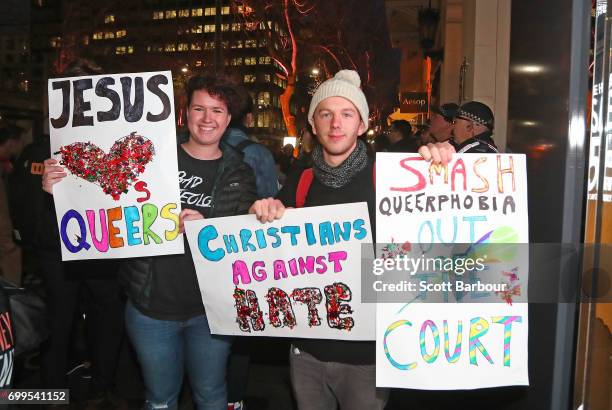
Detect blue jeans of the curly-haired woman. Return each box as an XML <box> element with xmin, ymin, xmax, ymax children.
<box><xmin>125</xmin><ymin>302</ymin><xmax>233</xmax><ymax>410</ymax></box>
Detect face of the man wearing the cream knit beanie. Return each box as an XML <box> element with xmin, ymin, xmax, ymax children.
<box><xmin>312</xmin><ymin>97</ymin><xmax>365</xmax><ymax>167</ymax></box>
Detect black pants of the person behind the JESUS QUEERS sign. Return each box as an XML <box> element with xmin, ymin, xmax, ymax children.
<box><xmin>40</xmin><ymin>252</ymin><xmax>125</xmax><ymax>395</ymax></box>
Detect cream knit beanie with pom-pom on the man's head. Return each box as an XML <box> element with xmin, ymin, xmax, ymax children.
<box><xmin>308</xmin><ymin>70</ymin><xmax>370</xmax><ymax>132</ymax></box>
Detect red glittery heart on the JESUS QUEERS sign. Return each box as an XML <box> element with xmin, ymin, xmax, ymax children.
<box><xmin>60</xmin><ymin>132</ymin><xmax>155</xmax><ymax>200</ymax></box>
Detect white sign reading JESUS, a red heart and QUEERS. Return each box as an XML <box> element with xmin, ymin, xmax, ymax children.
<box><xmin>48</xmin><ymin>71</ymin><xmax>183</xmax><ymax>260</ymax></box>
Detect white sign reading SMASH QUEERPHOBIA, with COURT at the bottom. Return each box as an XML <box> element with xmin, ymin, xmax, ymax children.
<box><xmin>376</xmin><ymin>154</ymin><xmax>529</xmax><ymax>390</ymax></box>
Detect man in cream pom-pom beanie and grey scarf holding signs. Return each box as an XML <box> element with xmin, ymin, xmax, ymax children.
<box><xmin>249</xmin><ymin>70</ymin><xmax>452</xmax><ymax>410</ymax></box>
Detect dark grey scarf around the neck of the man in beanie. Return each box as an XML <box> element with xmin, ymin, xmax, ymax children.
<box><xmin>312</xmin><ymin>139</ymin><xmax>368</xmax><ymax>188</ymax></box>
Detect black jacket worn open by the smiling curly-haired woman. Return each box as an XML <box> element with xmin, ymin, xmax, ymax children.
<box><xmin>119</xmin><ymin>144</ymin><xmax>257</xmax><ymax>310</ymax></box>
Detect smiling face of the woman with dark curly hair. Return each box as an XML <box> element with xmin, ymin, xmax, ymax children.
<box><xmin>187</xmin><ymin>90</ymin><xmax>232</xmax><ymax>146</ymax></box>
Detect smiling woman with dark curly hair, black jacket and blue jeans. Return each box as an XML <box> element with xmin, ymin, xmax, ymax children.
<box><xmin>43</xmin><ymin>74</ymin><xmax>257</xmax><ymax>410</ymax></box>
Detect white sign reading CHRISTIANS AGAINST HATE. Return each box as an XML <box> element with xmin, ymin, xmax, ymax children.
<box><xmin>185</xmin><ymin>203</ymin><xmax>375</xmax><ymax>340</ymax></box>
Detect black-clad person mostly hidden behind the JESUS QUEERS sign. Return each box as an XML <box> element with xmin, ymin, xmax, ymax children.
<box><xmin>35</xmin><ymin>59</ymin><xmax>125</xmax><ymax>409</ymax></box>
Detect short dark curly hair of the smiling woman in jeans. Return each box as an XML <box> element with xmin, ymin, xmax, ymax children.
<box><xmin>185</xmin><ymin>73</ymin><xmax>247</xmax><ymax>117</ymax></box>
